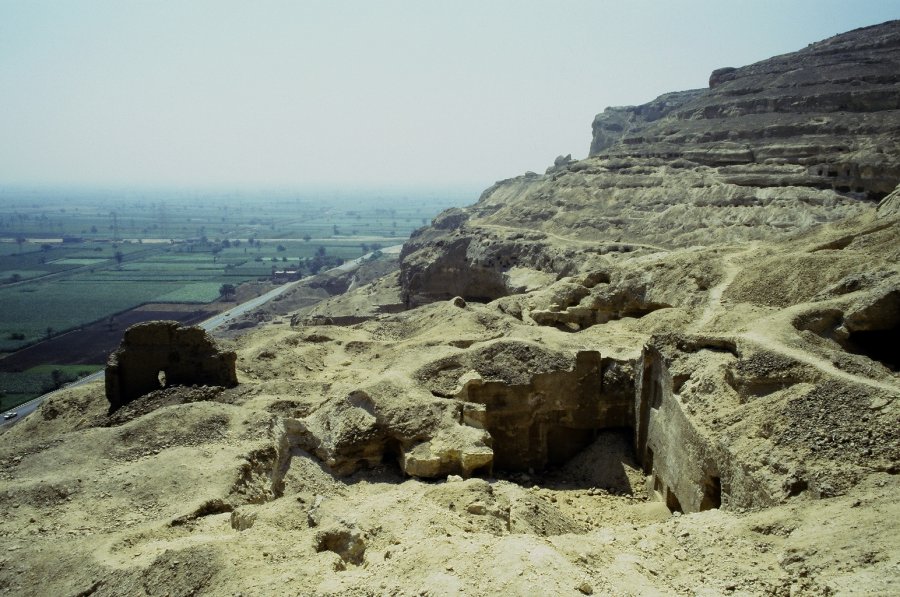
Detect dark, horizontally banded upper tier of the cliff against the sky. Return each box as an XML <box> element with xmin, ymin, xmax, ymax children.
<box><xmin>591</xmin><ymin>21</ymin><xmax>900</xmax><ymax>198</ymax></box>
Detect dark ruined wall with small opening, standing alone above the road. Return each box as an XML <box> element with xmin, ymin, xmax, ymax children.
<box><xmin>106</xmin><ymin>321</ymin><xmax>237</xmax><ymax>410</ymax></box>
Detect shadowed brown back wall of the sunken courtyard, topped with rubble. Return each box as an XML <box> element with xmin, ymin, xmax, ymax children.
<box><xmin>415</xmin><ymin>341</ymin><xmax>633</xmax><ymax>471</ymax></box>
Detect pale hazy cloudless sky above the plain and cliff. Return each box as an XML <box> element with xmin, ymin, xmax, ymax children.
<box><xmin>0</xmin><ymin>0</ymin><xmax>900</xmax><ymax>188</ymax></box>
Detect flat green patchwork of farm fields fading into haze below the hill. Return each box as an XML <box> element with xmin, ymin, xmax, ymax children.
<box><xmin>0</xmin><ymin>189</ymin><xmax>471</xmax><ymax>407</ymax></box>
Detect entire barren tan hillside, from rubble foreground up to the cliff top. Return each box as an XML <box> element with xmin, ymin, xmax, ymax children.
<box><xmin>0</xmin><ymin>21</ymin><xmax>900</xmax><ymax>595</ymax></box>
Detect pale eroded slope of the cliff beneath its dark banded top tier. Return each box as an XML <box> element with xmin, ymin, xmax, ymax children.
<box><xmin>400</xmin><ymin>157</ymin><xmax>871</xmax><ymax>306</ymax></box>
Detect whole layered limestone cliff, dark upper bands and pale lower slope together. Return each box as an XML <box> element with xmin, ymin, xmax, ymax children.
<box><xmin>400</xmin><ymin>21</ymin><xmax>900</xmax><ymax>306</ymax></box>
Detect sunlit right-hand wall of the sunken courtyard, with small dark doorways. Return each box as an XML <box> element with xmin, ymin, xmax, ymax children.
<box><xmin>634</xmin><ymin>335</ymin><xmax>789</xmax><ymax>512</ymax></box>
